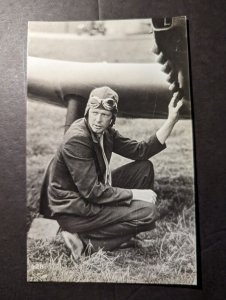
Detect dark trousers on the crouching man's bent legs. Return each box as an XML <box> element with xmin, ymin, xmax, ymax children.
<box><xmin>58</xmin><ymin>161</ymin><xmax>156</xmax><ymax>250</ymax></box>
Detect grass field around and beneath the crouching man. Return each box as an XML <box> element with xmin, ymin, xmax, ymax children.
<box><xmin>27</xmin><ymin>101</ymin><xmax>196</xmax><ymax>285</ymax></box>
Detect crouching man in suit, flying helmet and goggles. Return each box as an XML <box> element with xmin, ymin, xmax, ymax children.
<box><xmin>48</xmin><ymin>87</ymin><xmax>182</xmax><ymax>259</ymax></box>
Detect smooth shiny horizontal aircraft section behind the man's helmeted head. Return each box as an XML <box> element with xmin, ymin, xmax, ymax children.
<box><xmin>27</xmin><ymin>57</ymin><xmax>190</xmax><ymax>118</ymax></box>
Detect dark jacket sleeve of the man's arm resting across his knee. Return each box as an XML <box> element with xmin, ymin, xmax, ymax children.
<box><xmin>62</xmin><ymin>138</ymin><xmax>132</xmax><ymax>206</ymax></box>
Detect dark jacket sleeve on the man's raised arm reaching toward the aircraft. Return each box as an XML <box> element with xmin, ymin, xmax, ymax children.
<box><xmin>113</xmin><ymin>130</ymin><xmax>166</xmax><ymax>160</ymax></box>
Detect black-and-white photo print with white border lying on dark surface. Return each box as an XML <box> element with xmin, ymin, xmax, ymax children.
<box><xmin>27</xmin><ymin>17</ymin><xmax>197</xmax><ymax>286</ymax></box>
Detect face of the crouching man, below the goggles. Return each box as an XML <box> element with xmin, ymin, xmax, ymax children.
<box><xmin>88</xmin><ymin>108</ymin><xmax>112</xmax><ymax>134</ymax></box>
